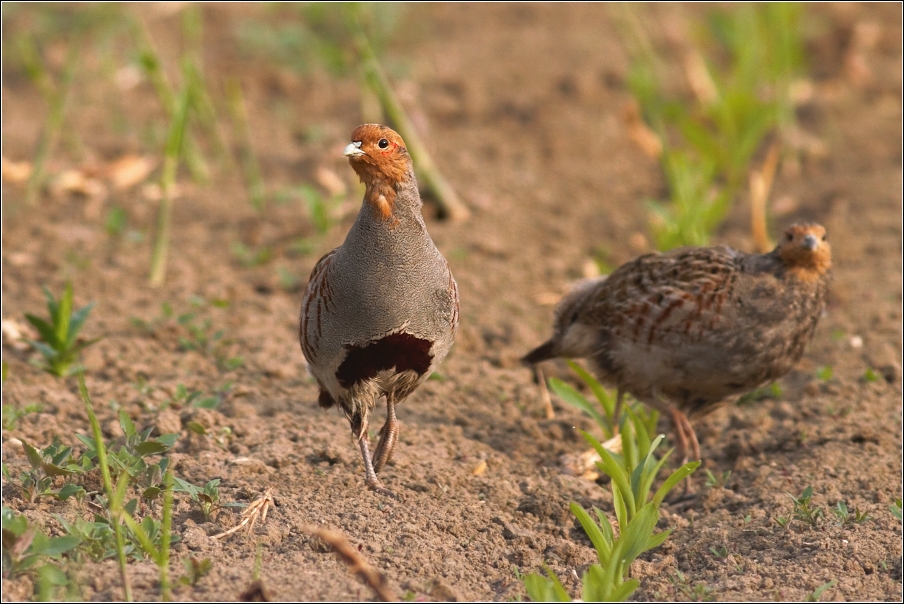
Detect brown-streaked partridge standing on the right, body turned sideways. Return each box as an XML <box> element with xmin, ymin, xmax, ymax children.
<box><xmin>522</xmin><ymin>224</ymin><xmax>832</xmax><ymax>459</ymax></box>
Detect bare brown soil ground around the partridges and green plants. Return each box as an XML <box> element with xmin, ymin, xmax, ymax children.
<box><xmin>2</xmin><ymin>4</ymin><xmax>902</xmax><ymax>600</ymax></box>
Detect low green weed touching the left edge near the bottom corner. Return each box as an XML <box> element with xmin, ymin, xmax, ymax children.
<box><xmin>0</xmin><ymin>506</ymin><xmax>78</xmax><ymax>579</ymax></box>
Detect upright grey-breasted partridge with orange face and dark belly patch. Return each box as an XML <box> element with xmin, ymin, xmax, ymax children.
<box><xmin>299</xmin><ymin>124</ymin><xmax>458</xmax><ymax>495</ymax></box>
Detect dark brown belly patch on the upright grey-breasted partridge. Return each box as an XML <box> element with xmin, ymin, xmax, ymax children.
<box><xmin>336</xmin><ymin>333</ymin><xmax>433</xmax><ymax>388</ymax></box>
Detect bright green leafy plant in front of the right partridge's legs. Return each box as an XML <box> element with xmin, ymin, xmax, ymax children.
<box><xmin>524</xmin><ymin>398</ymin><xmax>700</xmax><ymax>602</ymax></box>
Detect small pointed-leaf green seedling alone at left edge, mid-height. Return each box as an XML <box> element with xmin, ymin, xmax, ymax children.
<box><xmin>25</xmin><ymin>282</ymin><xmax>100</xmax><ymax>377</ymax></box>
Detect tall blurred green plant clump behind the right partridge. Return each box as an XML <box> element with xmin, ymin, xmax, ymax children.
<box><xmin>624</xmin><ymin>5</ymin><xmax>803</xmax><ymax>249</ymax></box>
